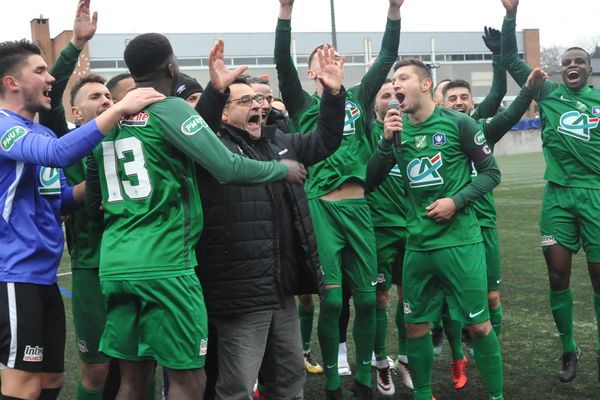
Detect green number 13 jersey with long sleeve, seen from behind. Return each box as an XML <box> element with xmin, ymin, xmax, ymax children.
<box><xmin>92</xmin><ymin>97</ymin><xmax>287</xmax><ymax>280</ymax></box>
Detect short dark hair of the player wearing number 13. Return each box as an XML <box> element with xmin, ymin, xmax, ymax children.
<box><xmin>123</xmin><ymin>33</ymin><xmax>173</xmax><ymax>81</ymax></box>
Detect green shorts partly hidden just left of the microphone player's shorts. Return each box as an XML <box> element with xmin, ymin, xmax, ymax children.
<box><xmin>375</xmin><ymin>226</ymin><xmax>407</xmax><ymax>290</ymax></box>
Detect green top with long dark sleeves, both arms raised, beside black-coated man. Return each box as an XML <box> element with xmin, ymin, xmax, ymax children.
<box><xmin>275</xmin><ymin>19</ymin><xmax>400</xmax><ymax>199</ymax></box>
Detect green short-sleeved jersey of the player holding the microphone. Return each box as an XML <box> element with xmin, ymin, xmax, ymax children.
<box><xmin>396</xmin><ymin>107</ymin><xmax>492</xmax><ymax>251</ymax></box>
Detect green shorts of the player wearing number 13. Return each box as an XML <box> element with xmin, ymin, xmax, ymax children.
<box><xmin>100</xmin><ymin>271</ymin><xmax>208</xmax><ymax>370</ymax></box>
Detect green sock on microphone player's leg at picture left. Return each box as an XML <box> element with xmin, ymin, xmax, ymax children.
<box><xmin>406</xmin><ymin>333</ymin><xmax>433</xmax><ymax>400</ymax></box>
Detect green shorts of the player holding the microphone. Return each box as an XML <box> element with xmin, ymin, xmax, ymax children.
<box><xmin>402</xmin><ymin>243</ymin><xmax>490</xmax><ymax>324</ymax></box>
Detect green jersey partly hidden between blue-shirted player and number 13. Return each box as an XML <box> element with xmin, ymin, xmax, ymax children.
<box><xmin>64</xmin><ymin>157</ymin><xmax>104</xmax><ymax>268</ymax></box>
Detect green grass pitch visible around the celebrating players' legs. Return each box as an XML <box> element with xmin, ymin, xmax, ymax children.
<box><xmin>54</xmin><ymin>153</ymin><xmax>600</xmax><ymax>400</ymax></box>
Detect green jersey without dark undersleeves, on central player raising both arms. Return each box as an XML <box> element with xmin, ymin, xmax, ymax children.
<box><xmin>291</xmin><ymin>91</ymin><xmax>371</xmax><ymax>199</ymax></box>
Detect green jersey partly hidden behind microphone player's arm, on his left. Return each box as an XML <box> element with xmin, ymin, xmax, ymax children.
<box><xmin>367</xmin><ymin>120</ymin><xmax>407</xmax><ymax>227</ymax></box>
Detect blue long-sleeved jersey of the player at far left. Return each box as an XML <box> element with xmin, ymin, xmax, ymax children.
<box><xmin>0</xmin><ymin>110</ymin><xmax>104</xmax><ymax>285</ymax></box>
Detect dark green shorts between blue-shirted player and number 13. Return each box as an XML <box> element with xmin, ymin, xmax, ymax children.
<box><xmin>72</xmin><ymin>268</ymin><xmax>110</xmax><ymax>363</ymax></box>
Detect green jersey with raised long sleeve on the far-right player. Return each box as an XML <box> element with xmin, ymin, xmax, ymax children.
<box><xmin>502</xmin><ymin>18</ymin><xmax>600</xmax><ymax>189</ymax></box>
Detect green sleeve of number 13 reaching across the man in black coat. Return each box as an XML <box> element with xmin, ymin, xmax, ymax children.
<box><xmin>148</xmin><ymin>97</ymin><xmax>287</xmax><ymax>183</ymax></box>
